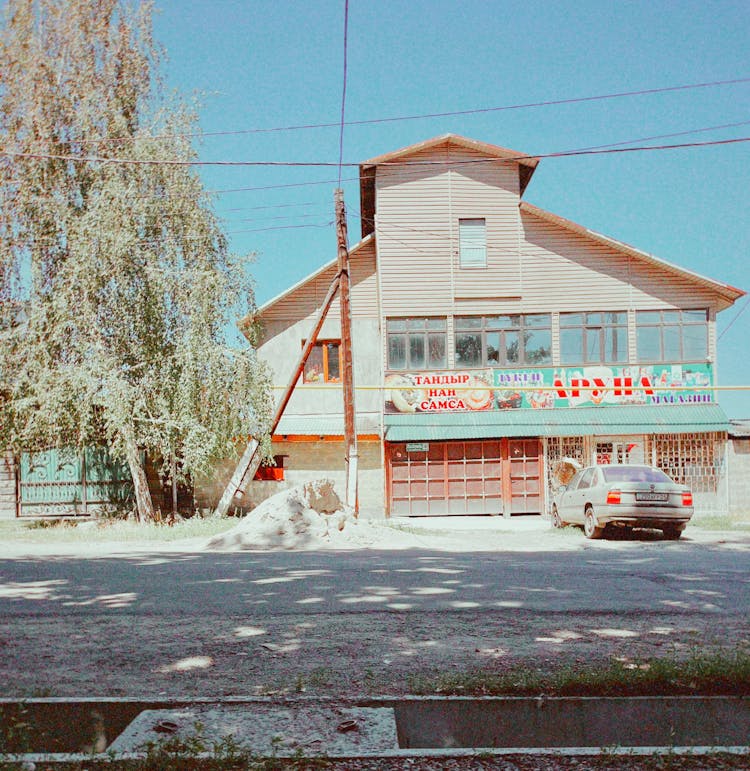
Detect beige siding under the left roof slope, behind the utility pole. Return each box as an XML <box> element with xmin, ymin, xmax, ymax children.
<box><xmin>263</xmin><ymin>242</ymin><xmax>378</xmax><ymax>321</ymax></box>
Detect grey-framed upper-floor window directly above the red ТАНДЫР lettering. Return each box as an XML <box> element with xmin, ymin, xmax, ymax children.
<box><xmin>386</xmin><ymin>317</ymin><xmax>448</xmax><ymax>370</ymax></box>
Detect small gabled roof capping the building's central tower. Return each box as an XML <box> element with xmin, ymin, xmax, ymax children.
<box><xmin>359</xmin><ymin>134</ymin><xmax>539</xmax><ymax>237</ymax></box>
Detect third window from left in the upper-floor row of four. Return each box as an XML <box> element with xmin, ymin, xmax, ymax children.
<box><xmin>560</xmin><ymin>311</ymin><xmax>628</xmax><ymax>364</ymax></box>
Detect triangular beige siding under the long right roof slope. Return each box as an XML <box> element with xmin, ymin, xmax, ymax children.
<box><xmin>521</xmin><ymin>212</ymin><xmax>716</xmax><ymax>311</ymax></box>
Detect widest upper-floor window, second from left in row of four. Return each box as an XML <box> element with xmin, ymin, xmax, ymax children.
<box><xmin>455</xmin><ymin>313</ymin><xmax>552</xmax><ymax>369</ymax></box>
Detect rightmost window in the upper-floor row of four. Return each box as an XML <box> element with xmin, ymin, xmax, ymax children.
<box><xmin>635</xmin><ymin>309</ymin><xmax>708</xmax><ymax>362</ymax></box>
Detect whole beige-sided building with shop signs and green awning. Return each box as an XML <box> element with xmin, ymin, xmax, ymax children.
<box><xmin>245</xmin><ymin>134</ymin><xmax>744</xmax><ymax>516</ymax></box>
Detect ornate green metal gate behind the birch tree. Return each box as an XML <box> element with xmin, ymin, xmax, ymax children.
<box><xmin>19</xmin><ymin>447</ymin><xmax>133</xmax><ymax>517</ymax></box>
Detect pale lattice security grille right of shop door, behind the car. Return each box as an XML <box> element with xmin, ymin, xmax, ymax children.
<box><xmin>647</xmin><ymin>432</ymin><xmax>727</xmax><ymax>493</ymax></box>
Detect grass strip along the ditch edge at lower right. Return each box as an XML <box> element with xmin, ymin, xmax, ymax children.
<box><xmin>409</xmin><ymin>650</ymin><xmax>750</xmax><ymax>696</ymax></box>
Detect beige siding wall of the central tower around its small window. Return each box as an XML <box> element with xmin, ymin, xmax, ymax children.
<box><xmin>375</xmin><ymin>145</ymin><xmax>520</xmax><ymax>316</ymax></box>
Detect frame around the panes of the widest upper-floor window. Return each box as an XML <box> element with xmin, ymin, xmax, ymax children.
<box><xmin>453</xmin><ymin>312</ymin><xmax>553</xmax><ymax>369</ymax></box>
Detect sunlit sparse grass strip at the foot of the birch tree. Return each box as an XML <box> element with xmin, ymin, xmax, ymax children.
<box><xmin>0</xmin><ymin>517</ymin><xmax>239</xmax><ymax>545</ymax></box>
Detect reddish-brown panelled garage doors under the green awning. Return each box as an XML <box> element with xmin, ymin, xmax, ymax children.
<box><xmin>386</xmin><ymin>438</ymin><xmax>543</xmax><ymax>517</ymax></box>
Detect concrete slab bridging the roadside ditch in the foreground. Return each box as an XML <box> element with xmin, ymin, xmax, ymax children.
<box><xmin>108</xmin><ymin>704</ymin><xmax>398</xmax><ymax>757</ymax></box>
